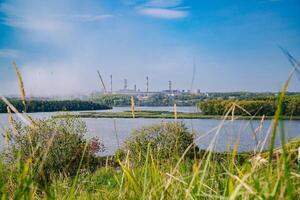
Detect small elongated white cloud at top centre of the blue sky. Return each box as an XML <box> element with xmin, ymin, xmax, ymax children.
<box><xmin>139</xmin><ymin>8</ymin><xmax>188</xmax><ymax>19</ymax></box>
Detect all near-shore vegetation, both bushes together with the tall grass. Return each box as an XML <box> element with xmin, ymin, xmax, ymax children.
<box><xmin>0</xmin><ymin>118</ymin><xmax>300</xmax><ymax>199</ymax></box>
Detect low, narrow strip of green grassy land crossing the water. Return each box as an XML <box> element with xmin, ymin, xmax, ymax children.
<box><xmin>53</xmin><ymin>111</ymin><xmax>300</xmax><ymax>120</ymax></box>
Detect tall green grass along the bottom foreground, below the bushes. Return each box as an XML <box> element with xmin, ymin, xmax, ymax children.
<box><xmin>0</xmin><ymin>140</ymin><xmax>300</xmax><ymax>199</ymax></box>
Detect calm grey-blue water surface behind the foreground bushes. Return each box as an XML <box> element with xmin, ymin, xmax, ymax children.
<box><xmin>0</xmin><ymin>107</ymin><xmax>300</xmax><ymax>155</ymax></box>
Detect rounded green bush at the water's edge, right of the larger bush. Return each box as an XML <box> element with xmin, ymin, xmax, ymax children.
<box><xmin>123</xmin><ymin>122</ymin><xmax>196</xmax><ymax>165</ymax></box>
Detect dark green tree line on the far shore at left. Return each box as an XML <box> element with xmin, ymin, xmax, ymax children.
<box><xmin>0</xmin><ymin>99</ymin><xmax>111</xmax><ymax>113</ymax></box>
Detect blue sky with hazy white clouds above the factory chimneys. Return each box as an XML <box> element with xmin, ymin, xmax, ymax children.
<box><xmin>0</xmin><ymin>0</ymin><xmax>300</xmax><ymax>96</ymax></box>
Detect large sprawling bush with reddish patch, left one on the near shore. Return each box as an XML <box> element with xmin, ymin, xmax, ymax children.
<box><xmin>2</xmin><ymin>118</ymin><xmax>104</xmax><ymax>181</ymax></box>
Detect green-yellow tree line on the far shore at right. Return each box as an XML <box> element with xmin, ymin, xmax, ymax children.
<box><xmin>197</xmin><ymin>96</ymin><xmax>300</xmax><ymax>116</ymax></box>
